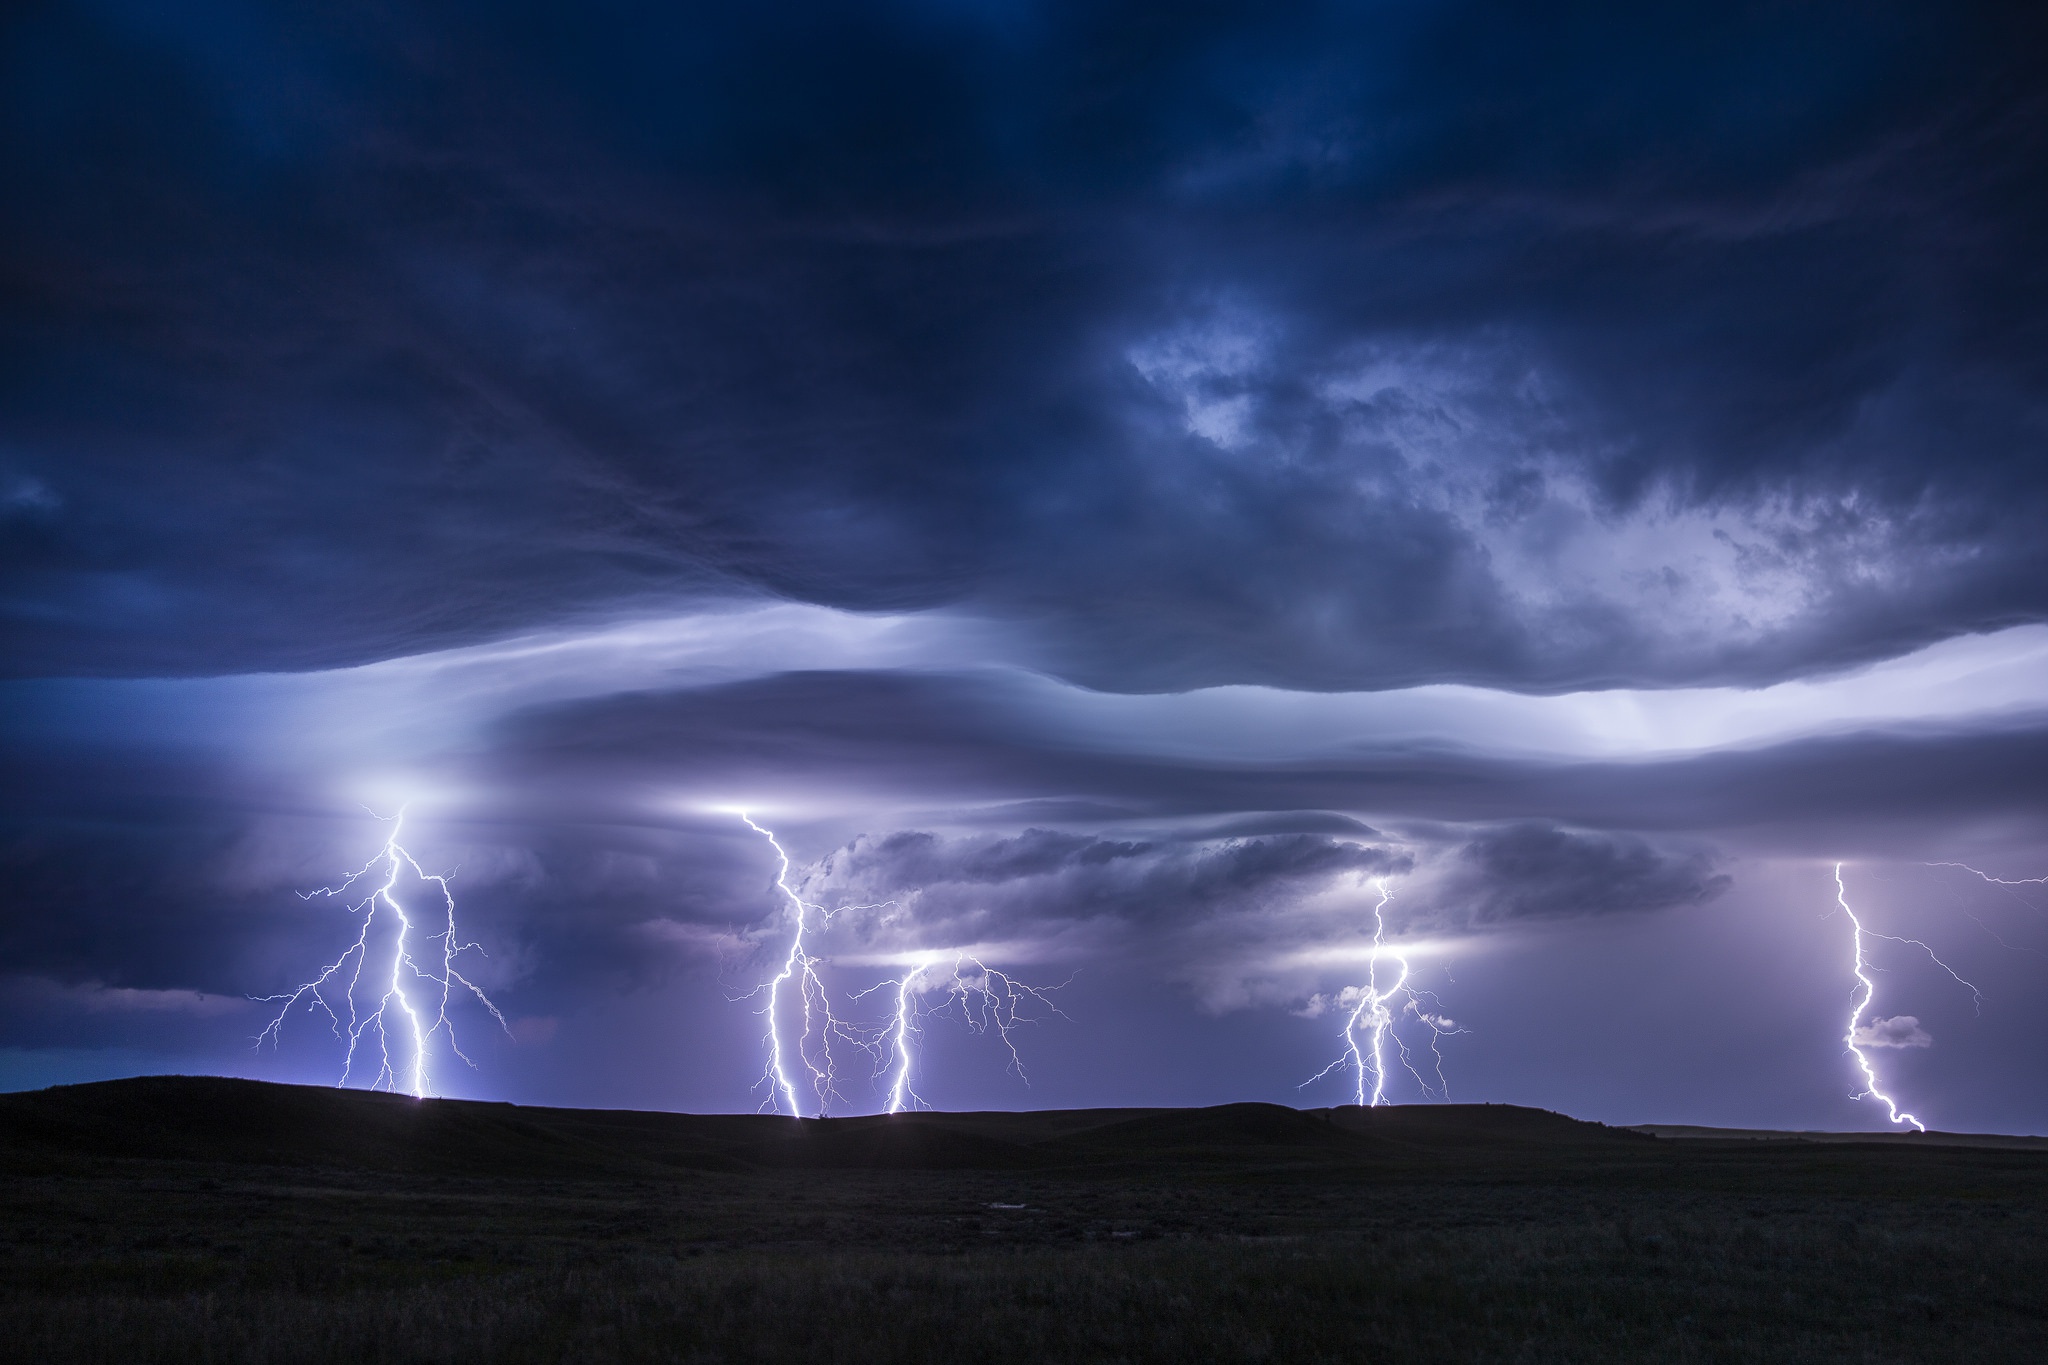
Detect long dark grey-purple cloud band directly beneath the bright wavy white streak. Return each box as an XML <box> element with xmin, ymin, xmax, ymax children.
<box><xmin>477</xmin><ymin>673</ymin><xmax>2048</xmax><ymax>849</ymax></box>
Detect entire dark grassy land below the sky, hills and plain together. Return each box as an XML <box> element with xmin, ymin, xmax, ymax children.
<box><xmin>0</xmin><ymin>1083</ymin><xmax>2048</xmax><ymax>1365</ymax></box>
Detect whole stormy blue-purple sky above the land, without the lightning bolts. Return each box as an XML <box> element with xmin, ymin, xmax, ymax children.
<box><xmin>0</xmin><ymin>0</ymin><xmax>2048</xmax><ymax>1132</ymax></box>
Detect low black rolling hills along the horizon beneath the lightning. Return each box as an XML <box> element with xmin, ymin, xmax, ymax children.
<box><xmin>0</xmin><ymin>1076</ymin><xmax>1651</xmax><ymax>1177</ymax></box>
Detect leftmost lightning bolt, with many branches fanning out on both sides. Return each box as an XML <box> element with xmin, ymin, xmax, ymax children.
<box><xmin>256</xmin><ymin>808</ymin><xmax>510</xmax><ymax>1099</ymax></box>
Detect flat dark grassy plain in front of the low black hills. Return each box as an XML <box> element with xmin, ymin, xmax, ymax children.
<box><xmin>0</xmin><ymin>1154</ymin><xmax>2048</xmax><ymax>1365</ymax></box>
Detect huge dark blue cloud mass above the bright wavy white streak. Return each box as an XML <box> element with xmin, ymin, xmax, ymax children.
<box><xmin>0</xmin><ymin>2</ymin><xmax>2048</xmax><ymax>688</ymax></box>
